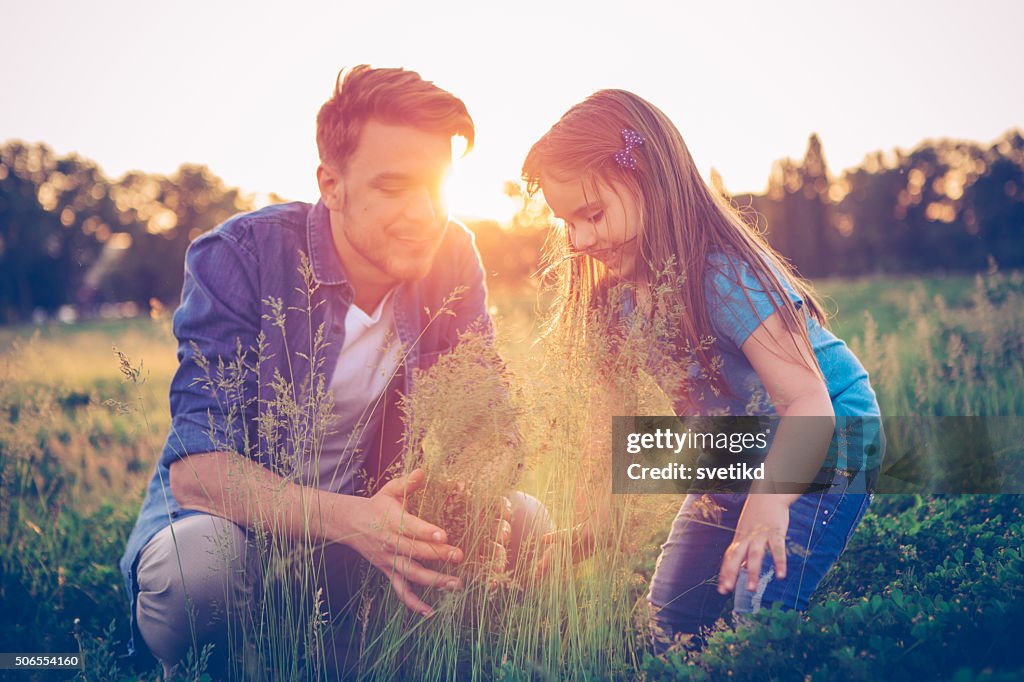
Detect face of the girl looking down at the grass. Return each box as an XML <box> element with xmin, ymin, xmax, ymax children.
<box><xmin>541</xmin><ymin>174</ymin><xmax>640</xmax><ymax>281</ymax></box>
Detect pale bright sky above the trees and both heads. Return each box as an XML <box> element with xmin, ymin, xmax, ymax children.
<box><xmin>0</xmin><ymin>0</ymin><xmax>1024</xmax><ymax>219</ymax></box>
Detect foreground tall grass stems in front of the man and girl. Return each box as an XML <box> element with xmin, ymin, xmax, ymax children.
<box><xmin>161</xmin><ymin>258</ymin><xmax>688</xmax><ymax>679</ymax></box>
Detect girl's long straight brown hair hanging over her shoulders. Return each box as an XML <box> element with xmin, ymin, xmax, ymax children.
<box><xmin>523</xmin><ymin>90</ymin><xmax>826</xmax><ymax>401</ymax></box>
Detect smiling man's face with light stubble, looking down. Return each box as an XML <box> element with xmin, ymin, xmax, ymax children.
<box><xmin>317</xmin><ymin>120</ymin><xmax>452</xmax><ymax>290</ymax></box>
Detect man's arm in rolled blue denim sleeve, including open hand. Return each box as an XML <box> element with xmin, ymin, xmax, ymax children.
<box><xmin>161</xmin><ymin>229</ymin><xmax>462</xmax><ymax>614</ymax></box>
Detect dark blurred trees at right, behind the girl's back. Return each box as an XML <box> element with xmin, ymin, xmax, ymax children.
<box><xmin>745</xmin><ymin>130</ymin><xmax>1024</xmax><ymax>278</ymax></box>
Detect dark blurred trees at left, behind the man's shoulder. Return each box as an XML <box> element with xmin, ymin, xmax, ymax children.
<box><xmin>0</xmin><ymin>141</ymin><xmax>252</xmax><ymax>323</ymax></box>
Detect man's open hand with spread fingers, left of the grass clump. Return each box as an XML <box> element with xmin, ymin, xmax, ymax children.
<box><xmin>338</xmin><ymin>469</ymin><xmax>463</xmax><ymax>616</ymax></box>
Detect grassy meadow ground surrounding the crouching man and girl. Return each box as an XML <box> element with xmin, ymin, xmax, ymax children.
<box><xmin>0</xmin><ymin>269</ymin><xmax>1024</xmax><ymax>682</ymax></box>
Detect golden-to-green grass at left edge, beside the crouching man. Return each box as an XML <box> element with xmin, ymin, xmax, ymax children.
<box><xmin>0</xmin><ymin>323</ymin><xmax>173</xmax><ymax>679</ymax></box>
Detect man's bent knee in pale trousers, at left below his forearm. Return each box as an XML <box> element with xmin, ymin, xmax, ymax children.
<box><xmin>136</xmin><ymin>514</ymin><xmax>257</xmax><ymax>663</ymax></box>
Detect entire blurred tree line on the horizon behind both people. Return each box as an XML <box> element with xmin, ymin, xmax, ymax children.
<box><xmin>0</xmin><ymin>130</ymin><xmax>1024</xmax><ymax>324</ymax></box>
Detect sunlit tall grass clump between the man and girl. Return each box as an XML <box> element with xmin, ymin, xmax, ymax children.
<box><xmin>346</xmin><ymin>284</ymin><xmax>688</xmax><ymax>680</ymax></box>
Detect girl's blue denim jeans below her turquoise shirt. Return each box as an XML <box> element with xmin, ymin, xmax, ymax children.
<box><xmin>647</xmin><ymin>471</ymin><xmax>873</xmax><ymax>653</ymax></box>
